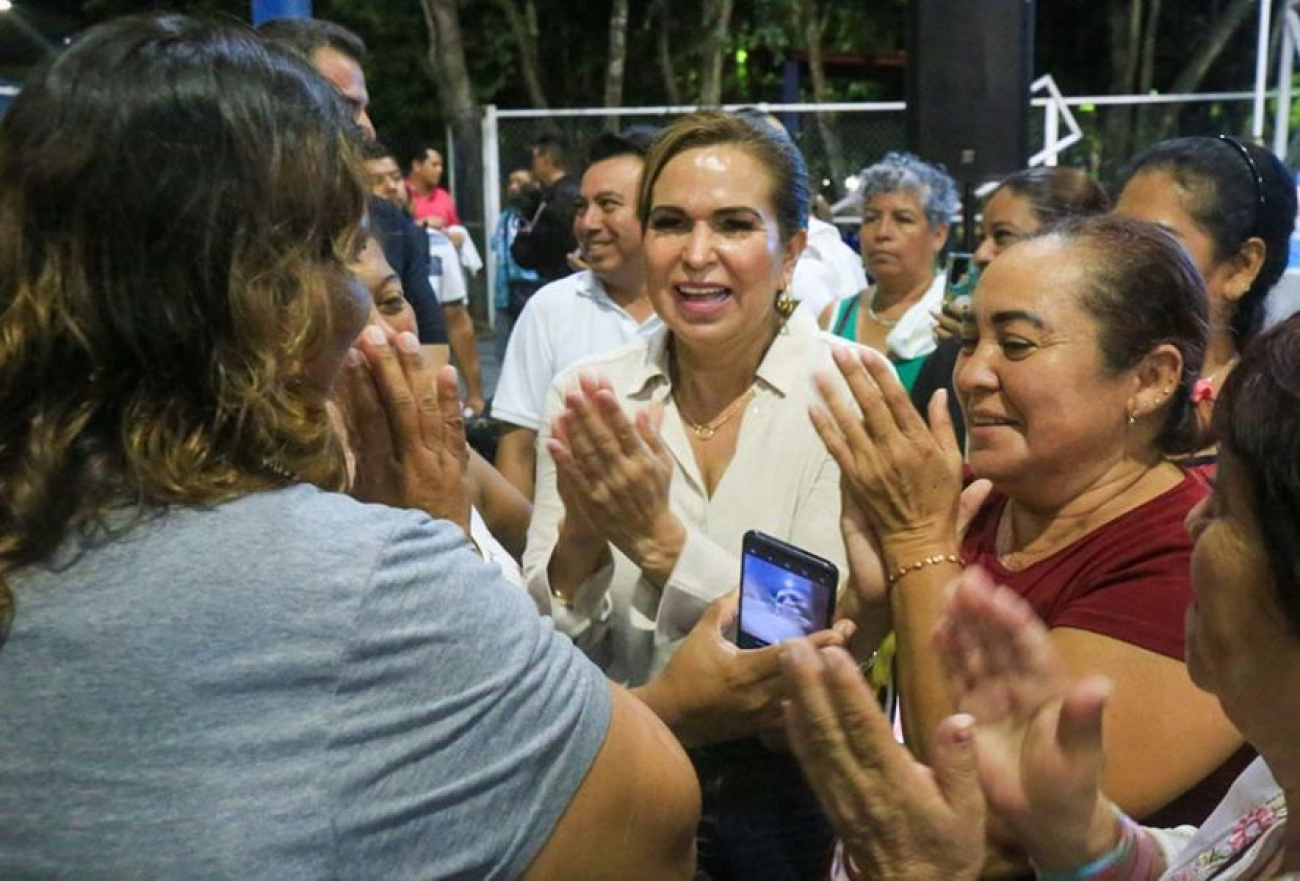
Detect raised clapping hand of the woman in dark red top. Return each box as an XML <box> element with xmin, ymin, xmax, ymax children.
<box><xmin>811</xmin><ymin>348</ymin><xmax>962</xmax><ymax>565</ymax></box>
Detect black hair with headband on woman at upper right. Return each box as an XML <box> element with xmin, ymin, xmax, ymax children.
<box><xmin>1119</xmin><ymin>136</ymin><xmax>1296</xmax><ymax>348</ymax></box>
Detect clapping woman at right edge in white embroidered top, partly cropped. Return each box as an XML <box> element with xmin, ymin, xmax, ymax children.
<box><xmin>788</xmin><ymin>316</ymin><xmax>1300</xmax><ymax>881</ymax></box>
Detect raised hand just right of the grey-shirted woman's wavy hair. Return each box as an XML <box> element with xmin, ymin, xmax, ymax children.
<box><xmin>338</xmin><ymin>325</ymin><xmax>471</xmax><ymax>535</ymax></box>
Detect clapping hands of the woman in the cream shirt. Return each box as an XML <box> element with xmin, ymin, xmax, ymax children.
<box><xmin>547</xmin><ymin>376</ymin><xmax>685</xmax><ymax>582</ymax></box>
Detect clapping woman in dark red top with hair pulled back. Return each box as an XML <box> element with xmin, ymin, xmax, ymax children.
<box><xmin>818</xmin><ymin>216</ymin><xmax>1243</xmax><ymax>857</ymax></box>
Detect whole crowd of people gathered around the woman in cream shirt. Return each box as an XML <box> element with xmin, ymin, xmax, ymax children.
<box><xmin>0</xmin><ymin>8</ymin><xmax>1300</xmax><ymax>881</ymax></box>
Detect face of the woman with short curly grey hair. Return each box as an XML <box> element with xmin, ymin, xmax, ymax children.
<box><xmin>862</xmin><ymin>190</ymin><xmax>948</xmax><ymax>287</ymax></box>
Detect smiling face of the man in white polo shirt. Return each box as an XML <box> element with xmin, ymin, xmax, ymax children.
<box><xmin>573</xmin><ymin>155</ymin><xmax>645</xmax><ymax>290</ymax></box>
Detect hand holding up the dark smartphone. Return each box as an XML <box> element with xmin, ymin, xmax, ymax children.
<box><xmin>634</xmin><ymin>591</ymin><xmax>854</xmax><ymax>747</ymax></box>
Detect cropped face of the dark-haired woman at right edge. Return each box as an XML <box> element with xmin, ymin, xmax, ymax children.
<box><xmin>1186</xmin><ymin>452</ymin><xmax>1295</xmax><ymax>735</ymax></box>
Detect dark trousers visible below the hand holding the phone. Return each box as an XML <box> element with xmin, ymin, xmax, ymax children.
<box><xmin>690</xmin><ymin>739</ymin><xmax>835</xmax><ymax>881</ymax></box>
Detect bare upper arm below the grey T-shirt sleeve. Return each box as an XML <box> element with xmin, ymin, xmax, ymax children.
<box><xmin>524</xmin><ymin>683</ymin><xmax>699</xmax><ymax>881</ymax></box>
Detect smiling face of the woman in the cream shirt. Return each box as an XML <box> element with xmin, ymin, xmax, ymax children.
<box><xmin>645</xmin><ymin>144</ymin><xmax>805</xmax><ymax>353</ymax></box>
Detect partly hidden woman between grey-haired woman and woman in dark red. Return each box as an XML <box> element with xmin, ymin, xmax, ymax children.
<box><xmin>911</xmin><ymin>166</ymin><xmax>1110</xmax><ymax>438</ymax></box>
